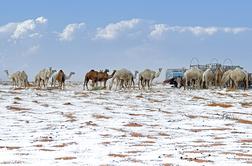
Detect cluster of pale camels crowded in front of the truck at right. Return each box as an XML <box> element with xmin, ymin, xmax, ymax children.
<box><xmin>181</xmin><ymin>66</ymin><xmax>249</xmax><ymax>90</ymax></box>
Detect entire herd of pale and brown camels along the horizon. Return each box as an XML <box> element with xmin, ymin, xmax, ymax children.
<box><xmin>2</xmin><ymin>66</ymin><xmax>249</xmax><ymax>90</ymax></box>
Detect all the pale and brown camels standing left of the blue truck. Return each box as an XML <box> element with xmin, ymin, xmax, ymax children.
<box><xmin>1</xmin><ymin>67</ymin><xmax>162</xmax><ymax>90</ymax></box>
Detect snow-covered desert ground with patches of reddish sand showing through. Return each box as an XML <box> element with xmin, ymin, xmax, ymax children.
<box><xmin>0</xmin><ymin>85</ymin><xmax>252</xmax><ymax>166</ymax></box>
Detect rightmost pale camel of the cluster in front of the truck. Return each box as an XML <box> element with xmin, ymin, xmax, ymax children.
<box><xmin>230</xmin><ymin>68</ymin><xmax>248</xmax><ymax>90</ymax></box>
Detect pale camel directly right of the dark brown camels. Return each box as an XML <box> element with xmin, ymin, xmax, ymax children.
<box><xmin>109</xmin><ymin>69</ymin><xmax>134</xmax><ymax>90</ymax></box>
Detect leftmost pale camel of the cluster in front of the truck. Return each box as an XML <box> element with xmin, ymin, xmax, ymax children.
<box><xmin>184</xmin><ymin>67</ymin><xmax>203</xmax><ymax>89</ymax></box>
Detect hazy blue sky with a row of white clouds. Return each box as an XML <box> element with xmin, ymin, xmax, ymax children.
<box><xmin>0</xmin><ymin>0</ymin><xmax>252</xmax><ymax>80</ymax></box>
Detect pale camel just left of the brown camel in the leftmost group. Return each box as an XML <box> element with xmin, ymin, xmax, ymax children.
<box><xmin>35</xmin><ymin>67</ymin><xmax>56</xmax><ymax>87</ymax></box>
